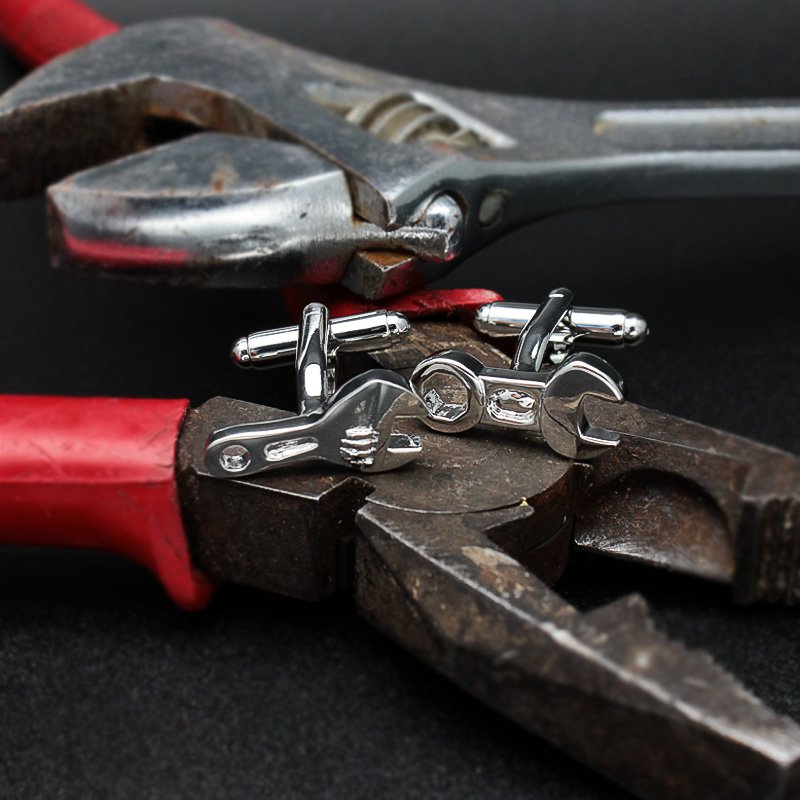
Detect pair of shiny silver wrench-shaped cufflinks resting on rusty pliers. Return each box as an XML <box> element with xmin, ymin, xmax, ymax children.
<box><xmin>206</xmin><ymin>289</ymin><xmax>647</xmax><ymax>478</ymax></box>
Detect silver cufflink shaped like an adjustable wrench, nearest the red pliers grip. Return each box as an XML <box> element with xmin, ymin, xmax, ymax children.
<box><xmin>206</xmin><ymin>303</ymin><xmax>425</xmax><ymax>478</ymax></box>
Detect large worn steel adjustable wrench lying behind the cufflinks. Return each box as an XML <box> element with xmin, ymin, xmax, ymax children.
<box><xmin>0</xmin><ymin>19</ymin><xmax>800</xmax><ymax>298</ymax></box>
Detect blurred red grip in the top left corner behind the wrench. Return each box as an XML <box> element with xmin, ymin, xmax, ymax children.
<box><xmin>0</xmin><ymin>0</ymin><xmax>119</xmax><ymax>67</ymax></box>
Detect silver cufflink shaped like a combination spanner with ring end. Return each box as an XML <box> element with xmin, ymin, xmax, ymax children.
<box><xmin>411</xmin><ymin>289</ymin><xmax>647</xmax><ymax>459</ymax></box>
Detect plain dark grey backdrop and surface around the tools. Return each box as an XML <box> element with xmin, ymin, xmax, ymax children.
<box><xmin>0</xmin><ymin>0</ymin><xmax>800</xmax><ymax>800</ymax></box>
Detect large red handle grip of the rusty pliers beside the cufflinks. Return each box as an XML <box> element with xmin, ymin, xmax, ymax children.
<box><xmin>0</xmin><ymin>395</ymin><xmax>213</xmax><ymax>609</ymax></box>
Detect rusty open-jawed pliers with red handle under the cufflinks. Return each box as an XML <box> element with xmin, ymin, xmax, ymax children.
<box><xmin>0</xmin><ymin>300</ymin><xmax>800</xmax><ymax>800</ymax></box>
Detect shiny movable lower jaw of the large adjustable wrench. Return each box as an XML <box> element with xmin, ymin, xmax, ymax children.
<box><xmin>43</xmin><ymin>131</ymin><xmax>460</xmax><ymax>294</ymax></box>
